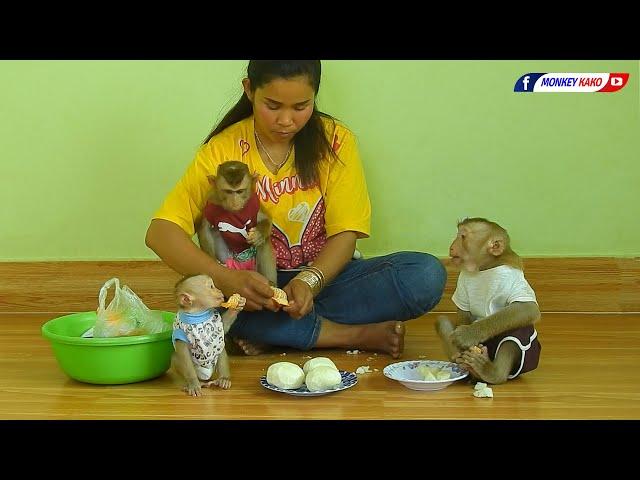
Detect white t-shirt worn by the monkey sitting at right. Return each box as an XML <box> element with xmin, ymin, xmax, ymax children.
<box><xmin>451</xmin><ymin>265</ymin><xmax>538</xmax><ymax>321</ymax></box>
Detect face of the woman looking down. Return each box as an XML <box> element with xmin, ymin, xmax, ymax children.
<box><xmin>245</xmin><ymin>76</ymin><xmax>315</xmax><ymax>143</ymax></box>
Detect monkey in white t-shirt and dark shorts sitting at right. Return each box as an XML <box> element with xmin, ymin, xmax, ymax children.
<box><xmin>436</xmin><ymin>218</ymin><xmax>542</xmax><ymax>384</ymax></box>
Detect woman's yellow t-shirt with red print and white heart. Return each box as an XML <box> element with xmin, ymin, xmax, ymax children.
<box><xmin>153</xmin><ymin>116</ymin><xmax>371</xmax><ymax>269</ymax></box>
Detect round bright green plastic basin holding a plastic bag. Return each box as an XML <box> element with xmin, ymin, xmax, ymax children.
<box><xmin>42</xmin><ymin>312</ymin><xmax>175</xmax><ymax>385</ymax></box>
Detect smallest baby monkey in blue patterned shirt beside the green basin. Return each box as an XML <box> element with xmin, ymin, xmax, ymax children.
<box><xmin>171</xmin><ymin>275</ymin><xmax>246</xmax><ymax>397</ymax></box>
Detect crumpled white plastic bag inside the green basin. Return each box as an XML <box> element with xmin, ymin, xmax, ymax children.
<box><xmin>93</xmin><ymin>278</ymin><xmax>171</xmax><ymax>337</ymax></box>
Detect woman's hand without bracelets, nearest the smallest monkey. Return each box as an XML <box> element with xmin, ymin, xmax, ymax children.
<box><xmin>215</xmin><ymin>269</ymin><xmax>277</xmax><ymax>311</ymax></box>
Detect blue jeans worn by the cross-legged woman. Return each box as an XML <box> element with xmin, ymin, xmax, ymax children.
<box><xmin>229</xmin><ymin>252</ymin><xmax>447</xmax><ymax>350</ymax></box>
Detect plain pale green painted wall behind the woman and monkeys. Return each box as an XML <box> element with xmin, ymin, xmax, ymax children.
<box><xmin>0</xmin><ymin>60</ymin><xmax>640</xmax><ymax>260</ymax></box>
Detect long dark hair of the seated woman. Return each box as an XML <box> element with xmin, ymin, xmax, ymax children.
<box><xmin>204</xmin><ymin>60</ymin><xmax>338</xmax><ymax>185</ymax></box>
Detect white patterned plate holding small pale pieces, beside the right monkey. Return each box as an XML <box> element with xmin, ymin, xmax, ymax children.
<box><xmin>382</xmin><ymin>360</ymin><xmax>469</xmax><ymax>391</ymax></box>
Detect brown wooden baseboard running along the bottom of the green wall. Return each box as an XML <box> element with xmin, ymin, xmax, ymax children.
<box><xmin>0</xmin><ymin>258</ymin><xmax>640</xmax><ymax>313</ymax></box>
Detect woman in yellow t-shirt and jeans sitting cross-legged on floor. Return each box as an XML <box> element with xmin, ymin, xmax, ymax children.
<box><xmin>146</xmin><ymin>60</ymin><xmax>446</xmax><ymax>358</ymax></box>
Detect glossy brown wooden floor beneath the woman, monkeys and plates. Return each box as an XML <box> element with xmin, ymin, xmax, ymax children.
<box><xmin>0</xmin><ymin>313</ymin><xmax>640</xmax><ymax>420</ymax></box>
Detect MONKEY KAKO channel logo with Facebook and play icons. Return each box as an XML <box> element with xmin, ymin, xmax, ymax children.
<box><xmin>513</xmin><ymin>73</ymin><xmax>629</xmax><ymax>93</ymax></box>
